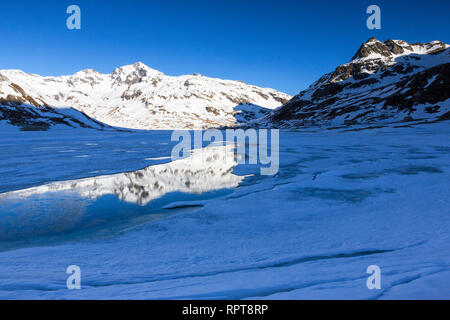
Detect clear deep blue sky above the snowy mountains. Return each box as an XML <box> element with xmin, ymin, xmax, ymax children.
<box><xmin>0</xmin><ymin>0</ymin><xmax>450</xmax><ymax>94</ymax></box>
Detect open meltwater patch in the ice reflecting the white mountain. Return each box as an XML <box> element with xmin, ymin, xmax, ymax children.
<box><xmin>0</xmin><ymin>145</ymin><xmax>245</xmax><ymax>242</ymax></box>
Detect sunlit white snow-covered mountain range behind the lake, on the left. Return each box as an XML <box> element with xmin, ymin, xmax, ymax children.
<box><xmin>0</xmin><ymin>62</ymin><xmax>291</xmax><ymax>129</ymax></box>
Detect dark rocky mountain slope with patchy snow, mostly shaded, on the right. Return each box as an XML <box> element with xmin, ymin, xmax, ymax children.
<box><xmin>252</xmin><ymin>38</ymin><xmax>450</xmax><ymax>128</ymax></box>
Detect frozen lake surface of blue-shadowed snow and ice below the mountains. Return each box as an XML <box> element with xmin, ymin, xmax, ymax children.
<box><xmin>0</xmin><ymin>122</ymin><xmax>450</xmax><ymax>299</ymax></box>
